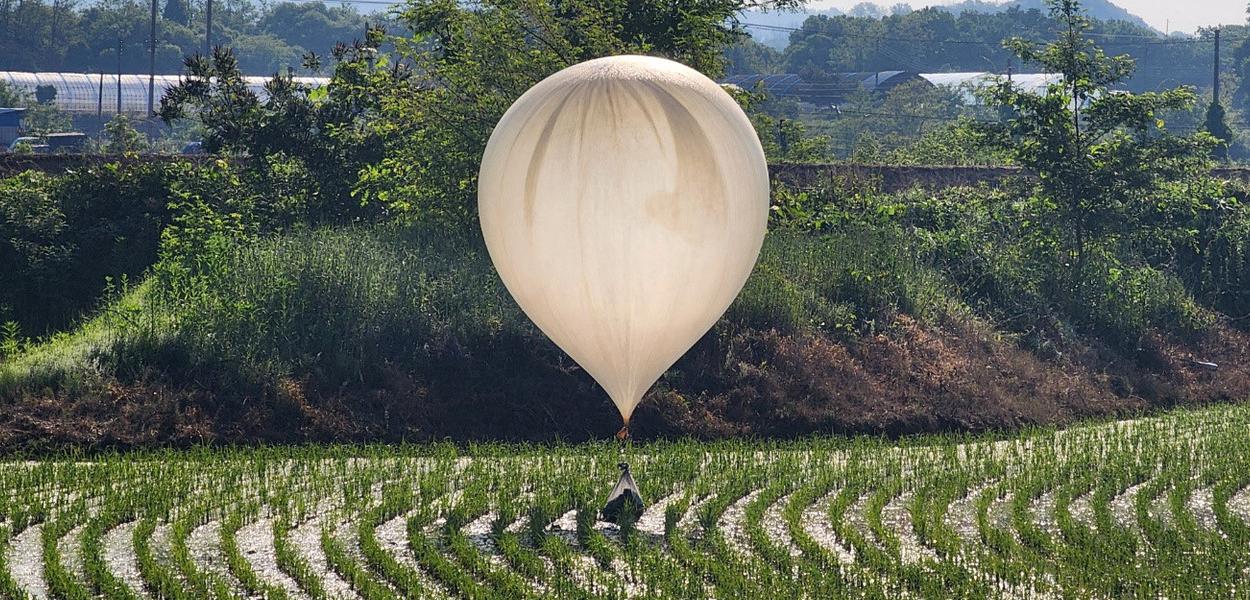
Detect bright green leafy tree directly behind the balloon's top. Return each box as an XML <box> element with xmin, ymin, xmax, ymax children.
<box><xmin>356</xmin><ymin>0</ymin><xmax>798</xmax><ymax>223</ymax></box>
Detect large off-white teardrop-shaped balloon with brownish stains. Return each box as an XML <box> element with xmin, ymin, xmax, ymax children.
<box><xmin>478</xmin><ymin>56</ymin><xmax>769</xmax><ymax>424</ymax></box>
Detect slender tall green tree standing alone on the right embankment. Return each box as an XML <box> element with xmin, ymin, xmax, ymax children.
<box><xmin>981</xmin><ymin>0</ymin><xmax>1214</xmax><ymax>306</ymax></box>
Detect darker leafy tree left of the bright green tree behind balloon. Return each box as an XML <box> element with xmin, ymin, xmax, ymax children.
<box><xmin>159</xmin><ymin>39</ymin><xmax>390</xmax><ymax>221</ymax></box>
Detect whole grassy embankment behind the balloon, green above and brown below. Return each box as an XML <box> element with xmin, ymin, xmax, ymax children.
<box><xmin>0</xmin><ymin>177</ymin><xmax>1250</xmax><ymax>446</ymax></box>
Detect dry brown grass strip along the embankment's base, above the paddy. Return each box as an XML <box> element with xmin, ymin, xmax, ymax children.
<box><xmin>0</xmin><ymin>315</ymin><xmax>1250</xmax><ymax>449</ymax></box>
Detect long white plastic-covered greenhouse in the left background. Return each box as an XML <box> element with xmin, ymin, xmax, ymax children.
<box><xmin>0</xmin><ymin>71</ymin><xmax>329</xmax><ymax>115</ymax></box>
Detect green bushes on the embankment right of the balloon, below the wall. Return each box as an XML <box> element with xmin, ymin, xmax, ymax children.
<box><xmin>765</xmin><ymin>168</ymin><xmax>1235</xmax><ymax>354</ymax></box>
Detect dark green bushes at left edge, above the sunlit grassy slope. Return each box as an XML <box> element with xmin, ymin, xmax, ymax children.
<box><xmin>0</xmin><ymin>156</ymin><xmax>332</xmax><ymax>336</ymax></box>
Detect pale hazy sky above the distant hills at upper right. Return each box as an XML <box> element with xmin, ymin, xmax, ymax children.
<box><xmin>809</xmin><ymin>0</ymin><xmax>1248</xmax><ymax>33</ymax></box>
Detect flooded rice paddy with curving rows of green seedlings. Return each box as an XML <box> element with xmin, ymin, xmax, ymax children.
<box><xmin>0</xmin><ymin>406</ymin><xmax>1250</xmax><ymax>600</ymax></box>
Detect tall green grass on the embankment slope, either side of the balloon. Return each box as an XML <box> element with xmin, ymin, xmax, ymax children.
<box><xmin>0</xmin><ymin>226</ymin><xmax>948</xmax><ymax>396</ymax></box>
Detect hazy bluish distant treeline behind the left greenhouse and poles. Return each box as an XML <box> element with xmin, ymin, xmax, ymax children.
<box><xmin>0</xmin><ymin>0</ymin><xmax>375</xmax><ymax>75</ymax></box>
